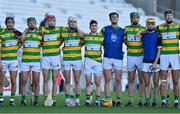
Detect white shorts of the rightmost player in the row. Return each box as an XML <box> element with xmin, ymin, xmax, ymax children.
<box><xmin>160</xmin><ymin>54</ymin><xmax>180</xmax><ymax>70</ymax></box>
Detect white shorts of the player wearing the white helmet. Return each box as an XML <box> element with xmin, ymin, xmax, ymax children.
<box><xmin>63</xmin><ymin>60</ymin><xmax>82</xmax><ymax>70</ymax></box>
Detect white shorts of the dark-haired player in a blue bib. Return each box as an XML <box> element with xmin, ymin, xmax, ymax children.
<box><xmin>103</xmin><ymin>57</ymin><xmax>123</xmax><ymax>70</ymax></box>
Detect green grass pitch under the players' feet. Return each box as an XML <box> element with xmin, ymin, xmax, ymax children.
<box><xmin>0</xmin><ymin>92</ymin><xmax>180</xmax><ymax>113</ymax></box>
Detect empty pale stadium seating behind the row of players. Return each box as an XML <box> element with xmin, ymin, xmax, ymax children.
<box><xmin>0</xmin><ymin>0</ymin><xmax>163</xmax><ymax>92</ymax></box>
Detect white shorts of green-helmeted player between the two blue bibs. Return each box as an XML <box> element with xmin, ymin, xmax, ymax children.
<box><xmin>127</xmin><ymin>56</ymin><xmax>143</xmax><ymax>71</ymax></box>
